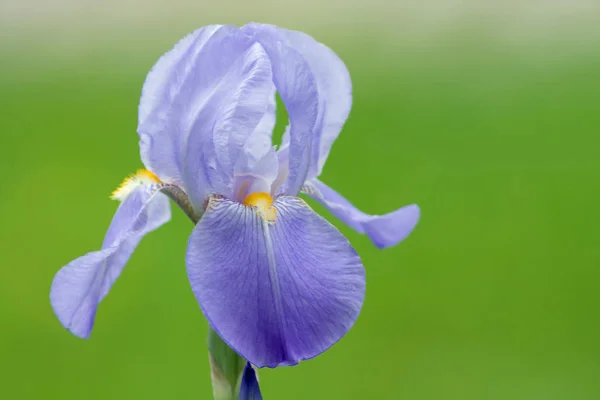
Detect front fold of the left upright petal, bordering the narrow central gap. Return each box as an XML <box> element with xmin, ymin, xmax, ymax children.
<box><xmin>177</xmin><ymin>27</ymin><xmax>273</xmax><ymax>205</ymax></box>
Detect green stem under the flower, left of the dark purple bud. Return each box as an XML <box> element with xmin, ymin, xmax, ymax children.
<box><xmin>208</xmin><ymin>327</ymin><xmax>246</xmax><ymax>400</ymax></box>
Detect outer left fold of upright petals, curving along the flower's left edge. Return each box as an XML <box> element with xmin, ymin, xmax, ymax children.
<box><xmin>138</xmin><ymin>25</ymin><xmax>221</xmax><ymax>184</ymax></box>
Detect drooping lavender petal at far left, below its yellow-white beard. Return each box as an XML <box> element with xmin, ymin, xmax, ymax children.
<box><xmin>50</xmin><ymin>186</ymin><xmax>171</xmax><ymax>338</ymax></box>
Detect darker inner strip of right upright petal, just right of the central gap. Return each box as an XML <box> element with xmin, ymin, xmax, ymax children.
<box><xmin>241</xmin><ymin>23</ymin><xmax>320</xmax><ymax>196</ymax></box>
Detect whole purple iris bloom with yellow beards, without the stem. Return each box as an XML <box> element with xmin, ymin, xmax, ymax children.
<box><xmin>50</xmin><ymin>23</ymin><xmax>419</xmax><ymax>367</ymax></box>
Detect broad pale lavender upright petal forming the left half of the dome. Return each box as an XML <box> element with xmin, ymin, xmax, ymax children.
<box><xmin>138</xmin><ymin>26</ymin><xmax>274</xmax><ymax>209</ymax></box>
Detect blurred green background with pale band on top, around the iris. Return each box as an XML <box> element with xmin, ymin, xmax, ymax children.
<box><xmin>0</xmin><ymin>0</ymin><xmax>600</xmax><ymax>400</ymax></box>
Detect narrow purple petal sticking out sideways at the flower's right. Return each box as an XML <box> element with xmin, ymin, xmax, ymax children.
<box><xmin>302</xmin><ymin>179</ymin><xmax>420</xmax><ymax>248</ymax></box>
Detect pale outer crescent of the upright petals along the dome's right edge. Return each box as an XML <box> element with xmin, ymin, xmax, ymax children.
<box><xmin>275</xmin><ymin>28</ymin><xmax>352</xmax><ymax>179</ymax></box>
